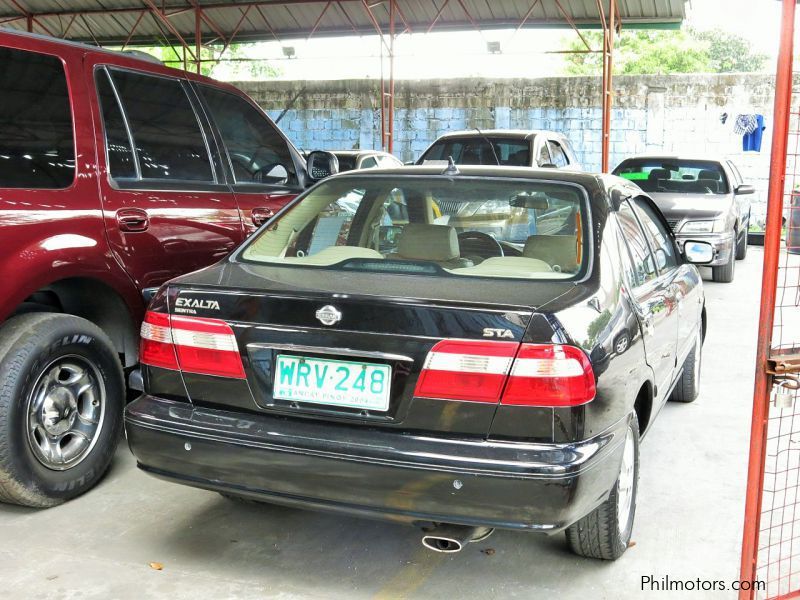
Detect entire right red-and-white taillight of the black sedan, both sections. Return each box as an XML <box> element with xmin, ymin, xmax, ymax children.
<box><xmin>414</xmin><ymin>340</ymin><xmax>596</xmax><ymax>407</ymax></box>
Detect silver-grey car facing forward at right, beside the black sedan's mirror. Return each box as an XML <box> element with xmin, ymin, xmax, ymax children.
<box><xmin>614</xmin><ymin>155</ymin><xmax>755</xmax><ymax>283</ymax></box>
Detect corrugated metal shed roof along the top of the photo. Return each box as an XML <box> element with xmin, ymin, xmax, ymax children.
<box><xmin>0</xmin><ymin>0</ymin><xmax>686</xmax><ymax>45</ymax></box>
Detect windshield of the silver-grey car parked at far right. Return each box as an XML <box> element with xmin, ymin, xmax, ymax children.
<box><xmin>614</xmin><ymin>158</ymin><xmax>728</xmax><ymax>194</ymax></box>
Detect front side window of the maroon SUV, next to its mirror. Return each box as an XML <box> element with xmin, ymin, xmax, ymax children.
<box><xmin>199</xmin><ymin>85</ymin><xmax>297</xmax><ymax>184</ymax></box>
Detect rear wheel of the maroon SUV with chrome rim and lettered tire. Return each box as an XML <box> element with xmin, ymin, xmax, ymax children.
<box><xmin>0</xmin><ymin>313</ymin><xmax>125</xmax><ymax>508</ymax></box>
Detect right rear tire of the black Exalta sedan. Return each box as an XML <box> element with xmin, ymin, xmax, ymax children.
<box><xmin>566</xmin><ymin>416</ymin><xmax>639</xmax><ymax>560</ymax></box>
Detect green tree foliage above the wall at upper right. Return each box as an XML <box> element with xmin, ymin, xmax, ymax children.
<box><xmin>564</xmin><ymin>29</ymin><xmax>767</xmax><ymax>75</ymax></box>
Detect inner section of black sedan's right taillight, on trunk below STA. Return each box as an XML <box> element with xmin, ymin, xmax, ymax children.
<box><xmin>414</xmin><ymin>340</ymin><xmax>519</xmax><ymax>403</ymax></box>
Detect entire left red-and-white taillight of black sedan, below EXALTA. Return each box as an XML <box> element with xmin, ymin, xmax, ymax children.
<box><xmin>139</xmin><ymin>312</ymin><xmax>245</xmax><ymax>379</ymax></box>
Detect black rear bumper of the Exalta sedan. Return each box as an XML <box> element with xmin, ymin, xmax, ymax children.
<box><xmin>125</xmin><ymin>395</ymin><xmax>627</xmax><ymax>533</ymax></box>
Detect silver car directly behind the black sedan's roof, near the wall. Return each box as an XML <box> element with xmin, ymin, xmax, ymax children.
<box><xmin>417</xmin><ymin>129</ymin><xmax>582</xmax><ymax>171</ymax></box>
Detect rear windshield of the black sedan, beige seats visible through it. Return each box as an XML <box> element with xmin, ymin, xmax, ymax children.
<box><xmin>241</xmin><ymin>176</ymin><xmax>589</xmax><ymax>279</ymax></box>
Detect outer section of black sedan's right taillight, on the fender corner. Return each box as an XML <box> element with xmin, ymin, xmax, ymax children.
<box><xmin>501</xmin><ymin>344</ymin><xmax>595</xmax><ymax>406</ymax></box>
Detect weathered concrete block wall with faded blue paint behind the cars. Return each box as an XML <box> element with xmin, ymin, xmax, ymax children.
<box><xmin>241</xmin><ymin>73</ymin><xmax>774</xmax><ymax>226</ymax></box>
